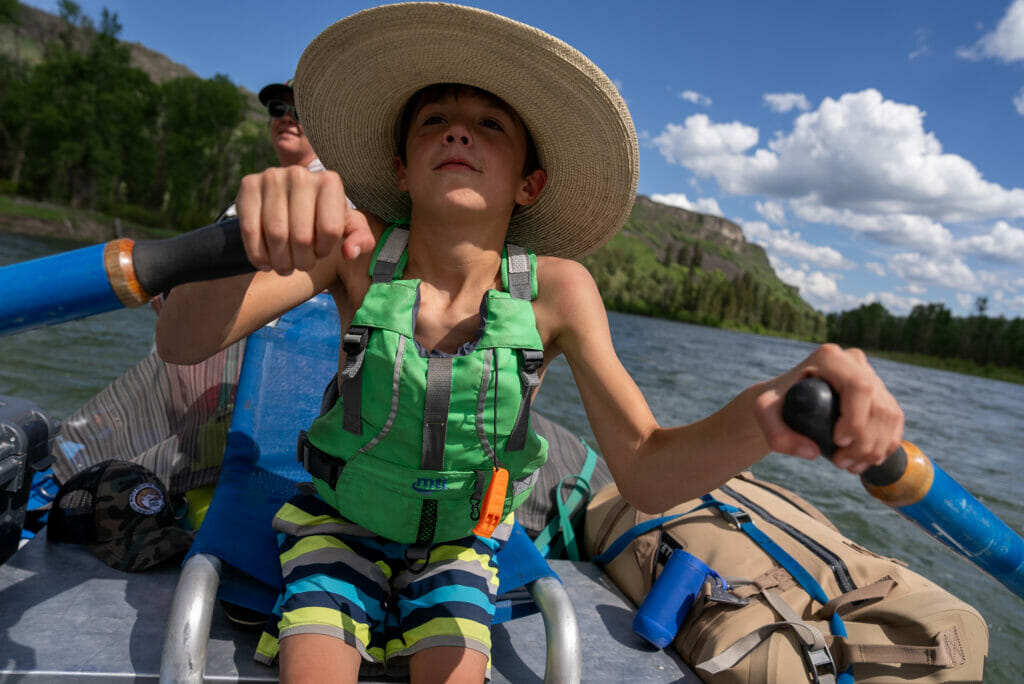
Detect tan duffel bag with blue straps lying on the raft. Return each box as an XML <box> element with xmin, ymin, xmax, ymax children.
<box><xmin>584</xmin><ymin>473</ymin><xmax>988</xmax><ymax>684</ymax></box>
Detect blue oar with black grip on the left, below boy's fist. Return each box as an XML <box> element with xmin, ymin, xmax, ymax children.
<box><xmin>0</xmin><ymin>219</ymin><xmax>253</xmax><ymax>336</ymax></box>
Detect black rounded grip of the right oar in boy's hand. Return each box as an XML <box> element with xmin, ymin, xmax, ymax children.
<box><xmin>782</xmin><ymin>377</ymin><xmax>906</xmax><ymax>486</ymax></box>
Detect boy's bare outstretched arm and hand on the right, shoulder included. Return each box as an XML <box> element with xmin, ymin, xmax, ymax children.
<box><xmin>539</xmin><ymin>260</ymin><xmax>902</xmax><ymax>512</ymax></box>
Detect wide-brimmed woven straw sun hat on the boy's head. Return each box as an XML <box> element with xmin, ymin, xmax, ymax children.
<box><xmin>294</xmin><ymin>2</ymin><xmax>639</xmax><ymax>258</ymax></box>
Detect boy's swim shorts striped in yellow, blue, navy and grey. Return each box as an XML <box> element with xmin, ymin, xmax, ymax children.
<box><xmin>255</xmin><ymin>485</ymin><xmax>513</xmax><ymax>676</ymax></box>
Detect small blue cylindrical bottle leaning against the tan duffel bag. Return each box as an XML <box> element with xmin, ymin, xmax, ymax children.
<box><xmin>633</xmin><ymin>549</ymin><xmax>718</xmax><ymax>648</ymax></box>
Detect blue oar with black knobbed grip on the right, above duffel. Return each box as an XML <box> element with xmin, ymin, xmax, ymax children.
<box><xmin>782</xmin><ymin>378</ymin><xmax>1024</xmax><ymax>598</ymax></box>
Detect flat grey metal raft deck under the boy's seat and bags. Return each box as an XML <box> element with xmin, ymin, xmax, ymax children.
<box><xmin>0</xmin><ymin>531</ymin><xmax>700</xmax><ymax>684</ymax></box>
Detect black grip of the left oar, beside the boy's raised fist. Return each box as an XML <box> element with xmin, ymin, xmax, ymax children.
<box><xmin>132</xmin><ymin>218</ymin><xmax>255</xmax><ymax>296</ymax></box>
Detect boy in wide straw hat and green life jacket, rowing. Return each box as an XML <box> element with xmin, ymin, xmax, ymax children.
<box><xmin>158</xmin><ymin>3</ymin><xmax>902</xmax><ymax>682</ymax></box>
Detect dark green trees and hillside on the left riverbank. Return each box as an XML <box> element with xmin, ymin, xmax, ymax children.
<box><xmin>0</xmin><ymin>0</ymin><xmax>275</xmax><ymax>229</ymax></box>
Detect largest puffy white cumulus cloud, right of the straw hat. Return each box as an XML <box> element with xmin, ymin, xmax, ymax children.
<box><xmin>652</xmin><ymin>87</ymin><xmax>1024</xmax><ymax>221</ymax></box>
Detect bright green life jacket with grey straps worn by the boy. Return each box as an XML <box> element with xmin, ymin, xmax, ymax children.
<box><xmin>299</xmin><ymin>225</ymin><xmax>548</xmax><ymax>544</ymax></box>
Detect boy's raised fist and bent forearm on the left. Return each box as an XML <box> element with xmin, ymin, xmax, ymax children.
<box><xmin>157</xmin><ymin>166</ymin><xmax>374</xmax><ymax>364</ymax></box>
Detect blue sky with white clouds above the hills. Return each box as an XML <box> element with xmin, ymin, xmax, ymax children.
<box><xmin>19</xmin><ymin>0</ymin><xmax>1024</xmax><ymax>318</ymax></box>
